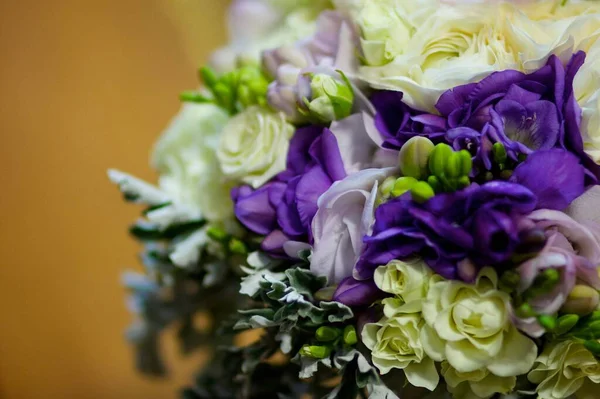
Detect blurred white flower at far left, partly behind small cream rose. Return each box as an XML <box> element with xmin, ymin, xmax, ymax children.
<box><xmin>152</xmin><ymin>104</ymin><xmax>233</xmax><ymax>221</ymax></box>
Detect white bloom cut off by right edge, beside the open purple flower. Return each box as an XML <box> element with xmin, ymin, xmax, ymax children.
<box><xmin>573</xmin><ymin>41</ymin><xmax>600</xmax><ymax>163</ymax></box>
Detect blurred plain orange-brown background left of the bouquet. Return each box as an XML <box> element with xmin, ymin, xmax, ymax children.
<box><xmin>0</xmin><ymin>0</ymin><xmax>227</xmax><ymax>399</ymax></box>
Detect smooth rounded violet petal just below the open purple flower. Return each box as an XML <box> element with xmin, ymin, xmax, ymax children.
<box><xmin>511</xmin><ymin>149</ymin><xmax>585</xmax><ymax>211</ymax></box>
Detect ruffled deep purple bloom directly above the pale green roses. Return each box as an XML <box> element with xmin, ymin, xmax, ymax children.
<box><xmin>354</xmin><ymin>181</ymin><xmax>537</xmax><ymax>280</ymax></box>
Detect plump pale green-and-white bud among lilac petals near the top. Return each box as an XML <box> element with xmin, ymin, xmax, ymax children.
<box><xmin>305</xmin><ymin>74</ymin><xmax>354</xmax><ymax>122</ymax></box>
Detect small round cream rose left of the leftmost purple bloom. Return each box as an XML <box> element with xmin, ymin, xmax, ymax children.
<box><xmin>217</xmin><ymin>106</ymin><xmax>294</xmax><ymax>188</ymax></box>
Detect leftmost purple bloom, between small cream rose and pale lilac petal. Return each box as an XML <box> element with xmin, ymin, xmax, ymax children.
<box><xmin>232</xmin><ymin>126</ymin><xmax>346</xmax><ymax>255</ymax></box>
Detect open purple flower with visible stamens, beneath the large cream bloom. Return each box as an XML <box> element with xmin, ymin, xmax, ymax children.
<box><xmin>436</xmin><ymin>52</ymin><xmax>600</xmax><ymax>185</ymax></box>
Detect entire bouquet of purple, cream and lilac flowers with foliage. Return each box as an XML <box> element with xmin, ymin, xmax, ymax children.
<box><xmin>110</xmin><ymin>0</ymin><xmax>600</xmax><ymax>399</ymax></box>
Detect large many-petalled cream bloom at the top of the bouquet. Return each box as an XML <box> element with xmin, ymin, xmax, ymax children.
<box><xmin>359</xmin><ymin>0</ymin><xmax>598</xmax><ymax>112</ymax></box>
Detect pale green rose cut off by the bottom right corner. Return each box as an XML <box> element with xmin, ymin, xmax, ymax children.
<box><xmin>527</xmin><ymin>341</ymin><xmax>600</xmax><ymax>399</ymax></box>
